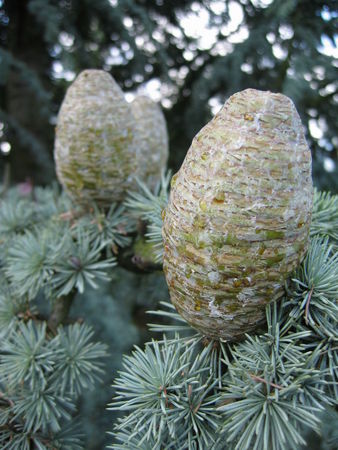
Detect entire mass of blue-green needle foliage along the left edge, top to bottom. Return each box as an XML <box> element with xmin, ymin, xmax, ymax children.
<box><xmin>0</xmin><ymin>185</ymin><xmax>143</xmax><ymax>450</ymax></box>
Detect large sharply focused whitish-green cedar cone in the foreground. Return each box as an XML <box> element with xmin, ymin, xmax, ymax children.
<box><xmin>163</xmin><ymin>89</ymin><xmax>312</xmax><ymax>340</ymax></box>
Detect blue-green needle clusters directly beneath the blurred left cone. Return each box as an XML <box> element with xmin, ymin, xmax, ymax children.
<box><xmin>0</xmin><ymin>189</ymin><xmax>136</xmax><ymax>300</ymax></box>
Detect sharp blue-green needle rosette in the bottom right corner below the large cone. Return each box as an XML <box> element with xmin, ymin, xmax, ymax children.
<box><xmin>219</xmin><ymin>306</ymin><xmax>330</xmax><ymax>450</ymax></box>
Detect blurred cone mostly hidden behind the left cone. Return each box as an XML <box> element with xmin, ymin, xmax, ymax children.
<box><xmin>131</xmin><ymin>96</ymin><xmax>168</xmax><ymax>188</ymax></box>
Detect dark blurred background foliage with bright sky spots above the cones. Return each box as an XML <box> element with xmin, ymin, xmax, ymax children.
<box><xmin>0</xmin><ymin>0</ymin><xmax>338</xmax><ymax>191</ymax></box>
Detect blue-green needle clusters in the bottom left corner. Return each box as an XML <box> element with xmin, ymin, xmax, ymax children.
<box><xmin>0</xmin><ymin>320</ymin><xmax>106</xmax><ymax>450</ymax></box>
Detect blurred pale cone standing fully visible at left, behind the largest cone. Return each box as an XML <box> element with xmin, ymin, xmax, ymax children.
<box><xmin>55</xmin><ymin>70</ymin><xmax>136</xmax><ymax>206</ymax></box>
